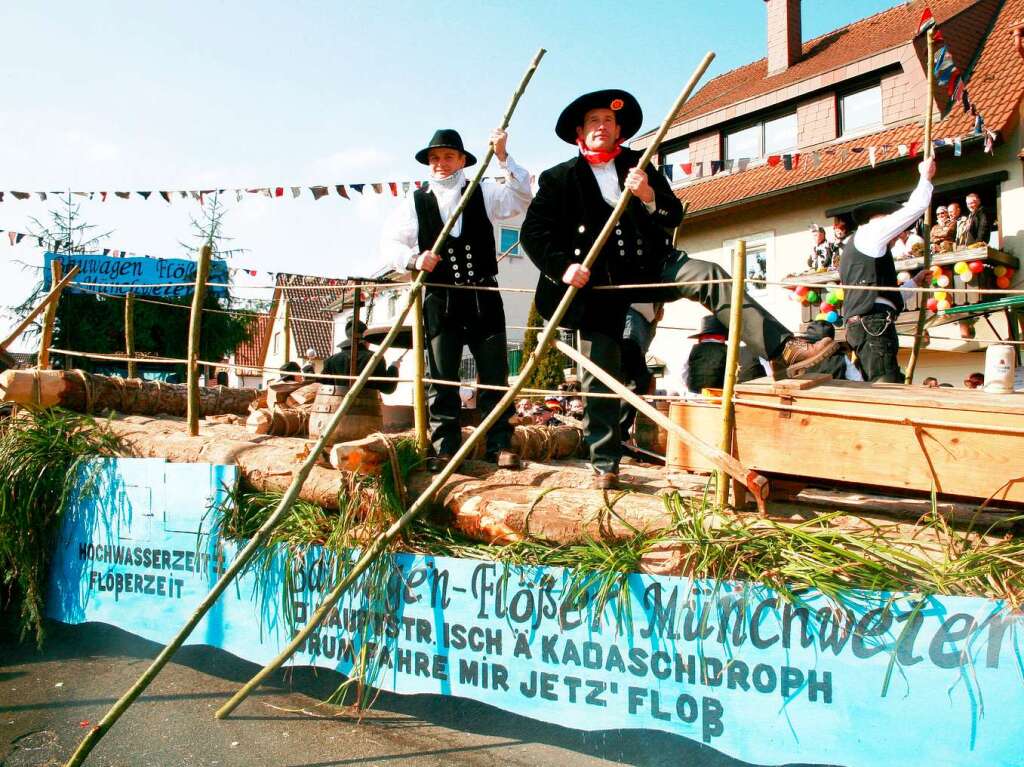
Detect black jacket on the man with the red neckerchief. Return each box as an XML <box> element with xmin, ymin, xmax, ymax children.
<box><xmin>520</xmin><ymin>148</ymin><xmax>683</xmax><ymax>337</ymax></box>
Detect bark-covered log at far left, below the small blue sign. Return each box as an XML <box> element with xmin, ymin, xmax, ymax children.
<box><xmin>0</xmin><ymin>370</ymin><xmax>256</xmax><ymax>416</ymax></box>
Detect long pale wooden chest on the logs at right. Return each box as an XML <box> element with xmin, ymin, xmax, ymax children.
<box><xmin>668</xmin><ymin>379</ymin><xmax>1024</xmax><ymax>503</ymax></box>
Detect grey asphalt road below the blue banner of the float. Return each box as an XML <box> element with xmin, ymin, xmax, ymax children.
<box><xmin>0</xmin><ymin>615</ymin><xmax>831</xmax><ymax>767</ymax></box>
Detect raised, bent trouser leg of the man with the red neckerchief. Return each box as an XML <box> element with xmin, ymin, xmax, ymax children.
<box><xmin>630</xmin><ymin>252</ymin><xmax>793</xmax><ymax>359</ymax></box>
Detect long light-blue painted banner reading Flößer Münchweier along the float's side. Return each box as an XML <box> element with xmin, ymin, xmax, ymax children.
<box><xmin>49</xmin><ymin>459</ymin><xmax>1024</xmax><ymax>767</ymax></box>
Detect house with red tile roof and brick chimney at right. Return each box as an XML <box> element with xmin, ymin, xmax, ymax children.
<box><xmin>633</xmin><ymin>0</ymin><xmax>1024</xmax><ymax>385</ymax></box>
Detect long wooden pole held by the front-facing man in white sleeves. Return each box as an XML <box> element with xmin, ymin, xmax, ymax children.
<box><xmin>66</xmin><ymin>48</ymin><xmax>545</xmax><ymax>767</ymax></box>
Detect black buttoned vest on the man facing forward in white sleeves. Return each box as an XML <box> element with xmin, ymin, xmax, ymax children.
<box><xmin>413</xmin><ymin>185</ymin><xmax>498</xmax><ymax>285</ymax></box>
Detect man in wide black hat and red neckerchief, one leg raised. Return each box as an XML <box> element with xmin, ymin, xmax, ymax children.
<box><xmin>521</xmin><ymin>89</ymin><xmax>835</xmax><ymax>487</ymax></box>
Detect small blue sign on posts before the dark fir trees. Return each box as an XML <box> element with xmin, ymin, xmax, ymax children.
<box><xmin>43</xmin><ymin>253</ymin><xmax>227</xmax><ymax>298</ymax></box>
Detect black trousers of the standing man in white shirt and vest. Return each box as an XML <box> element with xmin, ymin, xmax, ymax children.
<box><xmin>423</xmin><ymin>289</ymin><xmax>513</xmax><ymax>456</ymax></box>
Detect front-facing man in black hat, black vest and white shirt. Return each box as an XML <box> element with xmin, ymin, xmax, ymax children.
<box><xmin>381</xmin><ymin>129</ymin><xmax>532</xmax><ymax>471</ymax></box>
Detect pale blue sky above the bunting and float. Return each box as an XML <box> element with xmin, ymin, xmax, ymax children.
<box><xmin>0</xmin><ymin>0</ymin><xmax>895</xmax><ymax>344</ymax></box>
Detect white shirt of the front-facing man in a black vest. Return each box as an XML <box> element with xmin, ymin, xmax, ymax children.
<box><xmin>380</xmin><ymin>156</ymin><xmax>534</xmax><ymax>271</ymax></box>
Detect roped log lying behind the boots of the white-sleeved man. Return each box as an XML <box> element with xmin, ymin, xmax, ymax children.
<box><xmin>327</xmin><ymin>426</ymin><xmax>583</xmax><ymax>474</ymax></box>
